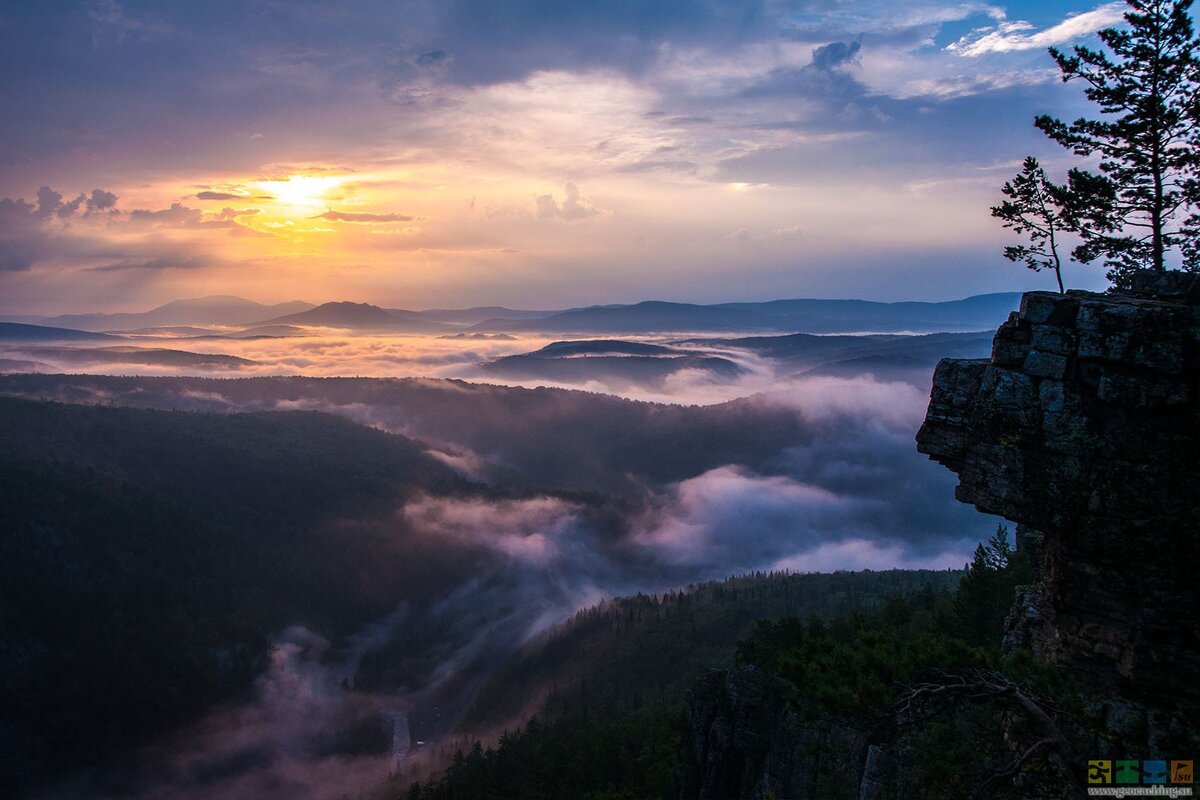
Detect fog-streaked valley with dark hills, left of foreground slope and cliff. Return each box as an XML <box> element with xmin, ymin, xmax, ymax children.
<box><xmin>0</xmin><ymin>302</ymin><xmax>994</xmax><ymax>799</ymax></box>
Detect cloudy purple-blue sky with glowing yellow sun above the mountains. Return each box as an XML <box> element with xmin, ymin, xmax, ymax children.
<box><xmin>0</xmin><ymin>0</ymin><xmax>1124</xmax><ymax>314</ymax></box>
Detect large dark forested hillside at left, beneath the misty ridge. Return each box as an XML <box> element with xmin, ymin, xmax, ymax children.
<box><xmin>0</xmin><ymin>399</ymin><xmax>470</xmax><ymax>792</ymax></box>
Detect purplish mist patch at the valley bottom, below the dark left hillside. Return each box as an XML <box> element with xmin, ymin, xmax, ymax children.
<box><xmin>73</xmin><ymin>623</ymin><xmax>410</xmax><ymax>800</ymax></box>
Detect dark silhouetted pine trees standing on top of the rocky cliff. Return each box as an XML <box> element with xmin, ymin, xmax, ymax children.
<box><xmin>992</xmin><ymin>0</ymin><xmax>1200</xmax><ymax>285</ymax></box>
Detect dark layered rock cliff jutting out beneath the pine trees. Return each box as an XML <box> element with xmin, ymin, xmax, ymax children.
<box><xmin>917</xmin><ymin>273</ymin><xmax>1200</xmax><ymax>727</ymax></box>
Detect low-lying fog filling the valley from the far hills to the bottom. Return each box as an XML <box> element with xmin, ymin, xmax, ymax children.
<box><xmin>9</xmin><ymin>321</ymin><xmax>995</xmax><ymax>800</ymax></box>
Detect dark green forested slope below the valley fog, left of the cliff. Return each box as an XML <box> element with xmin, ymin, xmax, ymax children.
<box><xmin>392</xmin><ymin>530</ymin><xmax>1055</xmax><ymax>800</ymax></box>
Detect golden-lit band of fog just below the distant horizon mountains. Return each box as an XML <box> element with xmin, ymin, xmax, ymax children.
<box><xmin>0</xmin><ymin>321</ymin><xmax>983</xmax><ymax>404</ymax></box>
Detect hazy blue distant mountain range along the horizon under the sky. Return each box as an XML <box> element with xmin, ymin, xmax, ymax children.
<box><xmin>4</xmin><ymin>291</ymin><xmax>1020</xmax><ymax>335</ymax></box>
